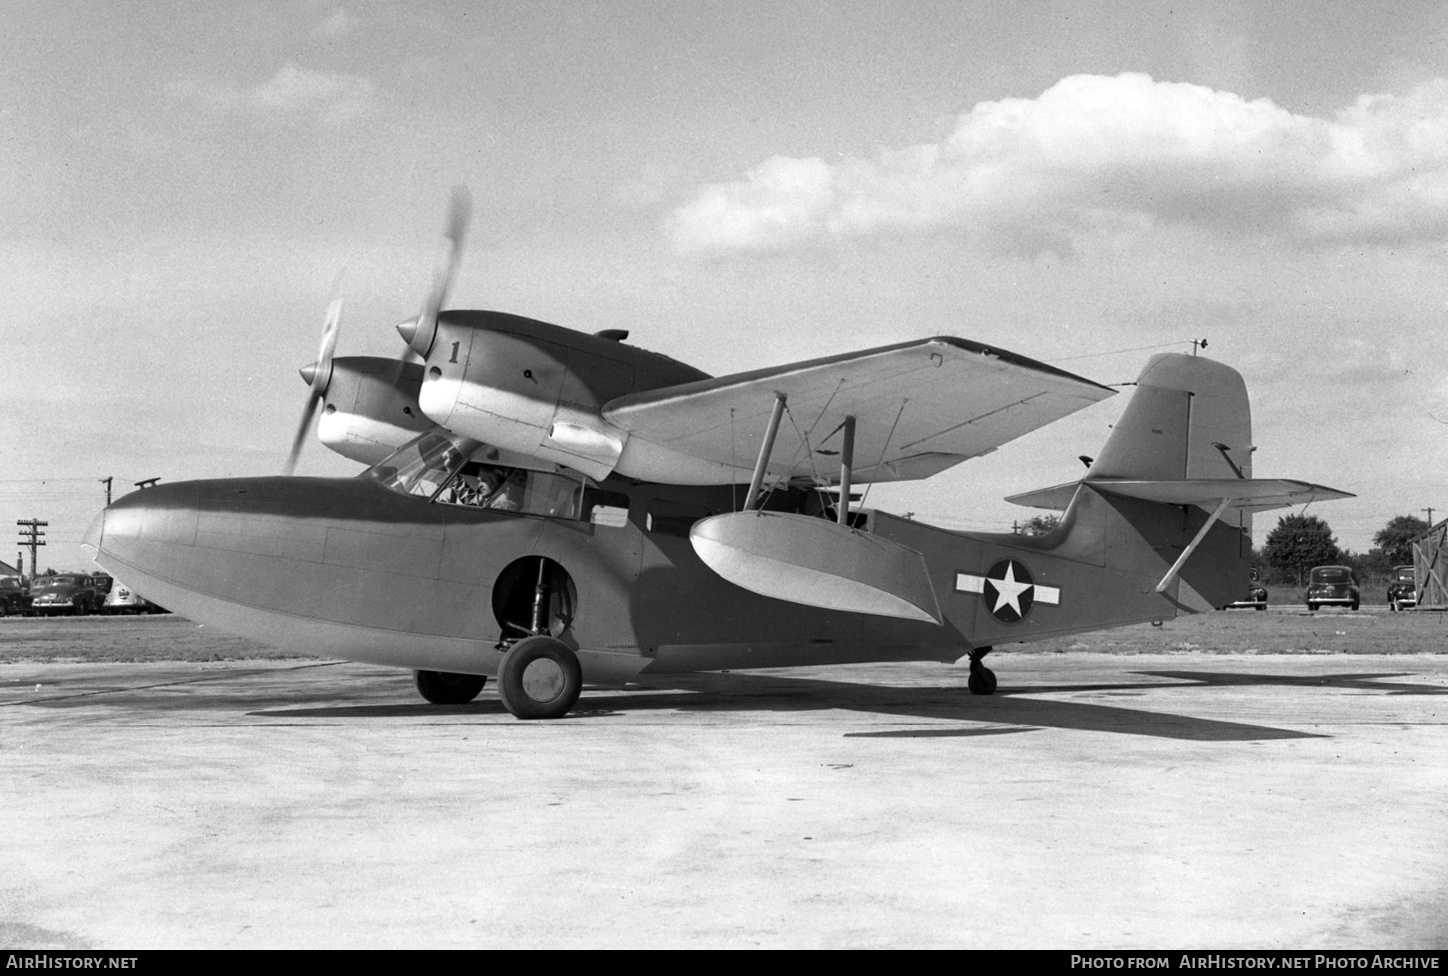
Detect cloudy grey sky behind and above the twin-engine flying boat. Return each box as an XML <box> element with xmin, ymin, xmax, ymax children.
<box><xmin>0</xmin><ymin>0</ymin><xmax>1448</xmax><ymax>568</ymax></box>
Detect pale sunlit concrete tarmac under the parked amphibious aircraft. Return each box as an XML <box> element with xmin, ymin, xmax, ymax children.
<box><xmin>0</xmin><ymin>652</ymin><xmax>1448</xmax><ymax>950</ymax></box>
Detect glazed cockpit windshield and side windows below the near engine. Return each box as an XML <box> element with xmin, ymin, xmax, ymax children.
<box><xmin>359</xmin><ymin>430</ymin><xmax>584</xmax><ymax>518</ymax></box>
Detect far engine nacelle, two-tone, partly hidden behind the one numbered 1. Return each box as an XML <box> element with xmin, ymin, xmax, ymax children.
<box><xmin>317</xmin><ymin>356</ymin><xmax>436</xmax><ymax>465</ymax></box>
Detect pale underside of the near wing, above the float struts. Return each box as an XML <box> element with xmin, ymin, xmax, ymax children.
<box><xmin>602</xmin><ymin>336</ymin><xmax>1115</xmax><ymax>481</ymax></box>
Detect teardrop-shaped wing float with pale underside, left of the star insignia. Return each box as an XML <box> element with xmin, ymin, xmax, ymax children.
<box><xmin>689</xmin><ymin>511</ymin><xmax>940</xmax><ymax>624</ymax></box>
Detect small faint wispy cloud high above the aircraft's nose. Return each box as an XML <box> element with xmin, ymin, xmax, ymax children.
<box><xmin>167</xmin><ymin>62</ymin><xmax>376</xmax><ymax>126</ymax></box>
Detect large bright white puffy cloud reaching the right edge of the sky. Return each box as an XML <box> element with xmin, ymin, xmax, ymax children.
<box><xmin>666</xmin><ymin>74</ymin><xmax>1448</xmax><ymax>251</ymax></box>
